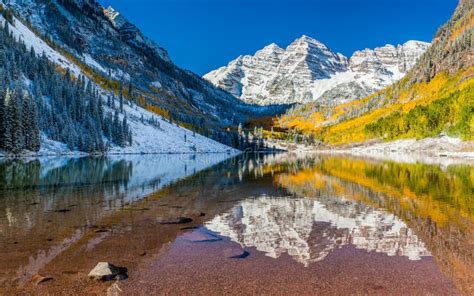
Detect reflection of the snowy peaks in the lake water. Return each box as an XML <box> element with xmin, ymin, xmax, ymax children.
<box><xmin>206</xmin><ymin>197</ymin><xmax>430</xmax><ymax>266</ymax></box>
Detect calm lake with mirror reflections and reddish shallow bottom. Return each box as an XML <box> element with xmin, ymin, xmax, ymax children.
<box><xmin>0</xmin><ymin>154</ymin><xmax>474</xmax><ymax>295</ymax></box>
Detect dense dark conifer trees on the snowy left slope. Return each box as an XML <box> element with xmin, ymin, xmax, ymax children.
<box><xmin>0</xmin><ymin>22</ymin><xmax>132</xmax><ymax>154</ymax></box>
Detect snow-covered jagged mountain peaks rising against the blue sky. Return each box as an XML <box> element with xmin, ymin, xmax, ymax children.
<box><xmin>204</xmin><ymin>36</ymin><xmax>430</xmax><ymax>105</ymax></box>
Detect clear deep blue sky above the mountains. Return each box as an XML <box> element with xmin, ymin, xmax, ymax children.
<box><xmin>99</xmin><ymin>0</ymin><xmax>457</xmax><ymax>75</ymax></box>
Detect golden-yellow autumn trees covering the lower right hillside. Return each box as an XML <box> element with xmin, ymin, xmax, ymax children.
<box><xmin>278</xmin><ymin>67</ymin><xmax>474</xmax><ymax>145</ymax></box>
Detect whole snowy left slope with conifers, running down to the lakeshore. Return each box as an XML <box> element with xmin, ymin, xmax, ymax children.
<box><xmin>0</xmin><ymin>10</ymin><xmax>237</xmax><ymax>156</ymax></box>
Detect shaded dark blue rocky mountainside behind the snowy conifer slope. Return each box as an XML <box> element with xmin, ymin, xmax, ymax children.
<box><xmin>0</xmin><ymin>0</ymin><xmax>284</xmax><ymax>134</ymax></box>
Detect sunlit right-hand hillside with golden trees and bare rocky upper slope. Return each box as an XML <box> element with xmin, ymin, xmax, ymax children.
<box><xmin>277</xmin><ymin>0</ymin><xmax>474</xmax><ymax>145</ymax></box>
